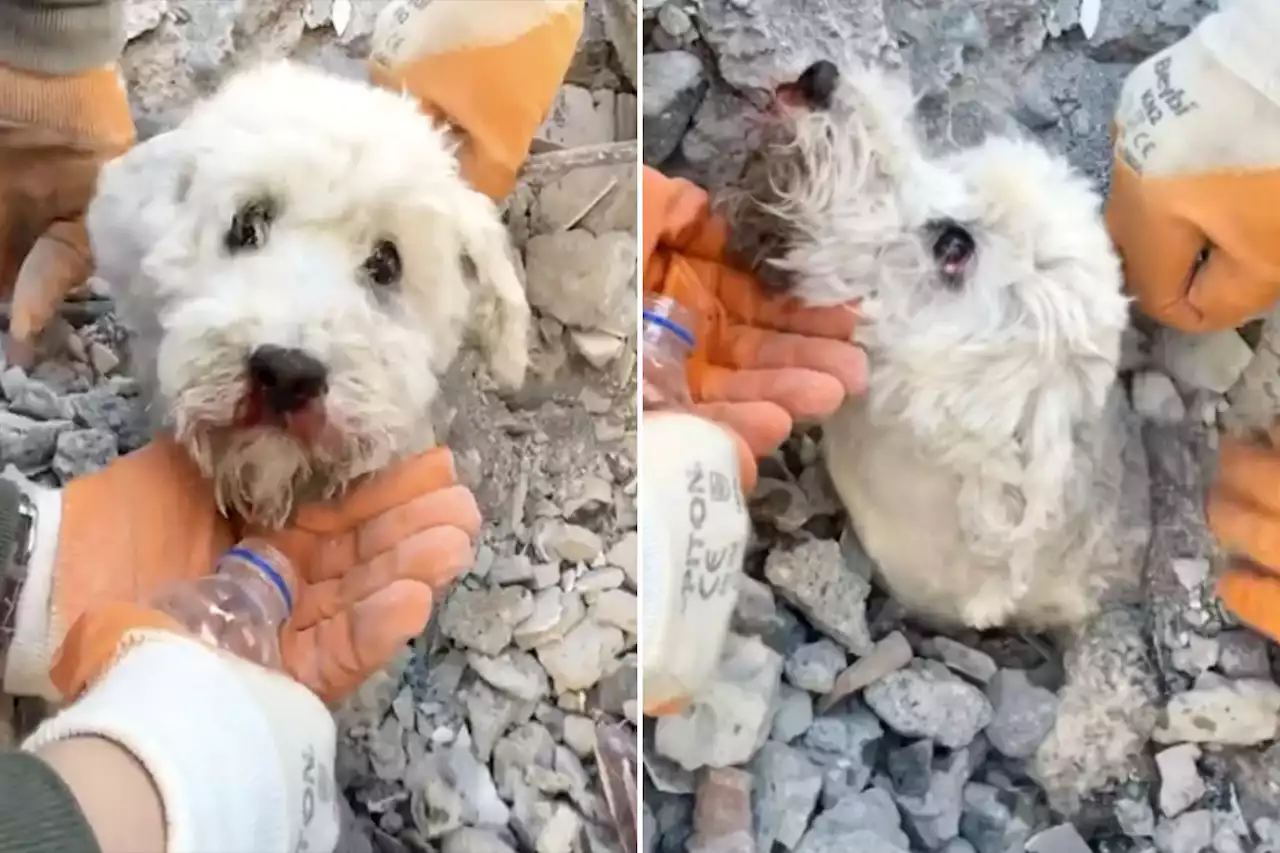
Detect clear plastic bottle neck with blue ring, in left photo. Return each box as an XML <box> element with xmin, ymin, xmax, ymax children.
<box><xmin>151</xmin><ymin>539</ymin><xmax>294</xmax><ymax>670</ymax></box>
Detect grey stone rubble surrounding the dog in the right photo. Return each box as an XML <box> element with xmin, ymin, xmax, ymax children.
<box><xmin>641</xmin><ymin>0</ymin><xmax>1280</xmax><ymax>853</ymax></box>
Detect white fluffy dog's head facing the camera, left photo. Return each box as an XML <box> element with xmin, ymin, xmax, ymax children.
<box><xmin>87</xmin><ymin>61</ymin><xmax>530</xmax><ymax>525</ymax></box>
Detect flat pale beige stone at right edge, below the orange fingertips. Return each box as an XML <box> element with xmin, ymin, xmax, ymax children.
<box><xmin>1152</xmin><ymin>679</ymin><xmax>1280</xmax><ymax>745</ymax></box>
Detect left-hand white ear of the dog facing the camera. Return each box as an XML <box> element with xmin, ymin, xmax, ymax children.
<box><xmin>84</xmin><ymin>129</ymin><xmax>195</xmax><ymax>300</ymax></box>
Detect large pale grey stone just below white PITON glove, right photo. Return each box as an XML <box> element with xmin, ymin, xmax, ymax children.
<box><xmin>654</xmin><ymin>634</ymin><xmax>782</xmax><ymax>770</ymax></box>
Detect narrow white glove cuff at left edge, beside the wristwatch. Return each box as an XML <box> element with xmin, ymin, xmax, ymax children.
<box><xmin>0</xmin><ymin>466</ymin><xmax>63</xmax><ymax>701</ymax></box>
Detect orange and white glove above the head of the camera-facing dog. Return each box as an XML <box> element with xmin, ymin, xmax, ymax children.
<box><xmin>369</xmin><ymin>0</ymin><xmax>585</xmax><ymax>201</ymax></box>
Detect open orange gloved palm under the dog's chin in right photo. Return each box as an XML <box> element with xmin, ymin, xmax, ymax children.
<box><xmin>643</xmin><ymin>169</ymin><xmax>867</xmax><ymax>479</ymax></box>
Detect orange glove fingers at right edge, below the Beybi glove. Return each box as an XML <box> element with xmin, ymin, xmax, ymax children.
<box><xmin>1208</xmin><ymin>427</ymin><xmax>1280</xmax><ymax>643</ymax></box>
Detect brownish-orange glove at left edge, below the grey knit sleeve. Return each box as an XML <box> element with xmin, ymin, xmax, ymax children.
<box><xmin>0</xmin><ymin>67</ymin><xmax>134</xmax><ymax>365</ymax></box>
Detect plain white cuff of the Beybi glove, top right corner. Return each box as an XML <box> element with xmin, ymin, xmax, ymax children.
<box><xmin>1196</xmin><ymin>0</ymin><xmax>1280</xmax><ymax>105</ymax></box>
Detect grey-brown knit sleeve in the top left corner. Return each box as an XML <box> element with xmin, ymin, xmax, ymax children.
<box><xmin>0</xmin><ymin>0</ymin><xmax>124</xmax><ymax>73</ymax></box>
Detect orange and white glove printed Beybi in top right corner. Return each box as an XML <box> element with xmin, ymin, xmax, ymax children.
<box><xmin>1106</xmin><ymin>0</ymin><xmax>1280</xmax><ymax>332</ymax></box>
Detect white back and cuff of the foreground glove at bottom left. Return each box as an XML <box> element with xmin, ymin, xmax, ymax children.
<box><xmin>22</xmin><ymin>631</ymin><xmax>337</xmax><ymax>853</ymax></box>
